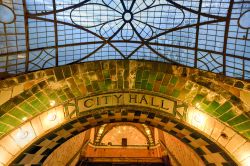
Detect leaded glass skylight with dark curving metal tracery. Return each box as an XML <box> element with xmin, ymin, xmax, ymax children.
<box><xmin>0</xmin><ymin>0</ymin><xmax>250</xmax><ymax>80</ymax></box>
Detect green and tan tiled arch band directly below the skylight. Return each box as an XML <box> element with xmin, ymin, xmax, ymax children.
<box><xmin>0</xmin><ymin>61</ymin><xmax>250</xmax><ymax>139</ymax></box>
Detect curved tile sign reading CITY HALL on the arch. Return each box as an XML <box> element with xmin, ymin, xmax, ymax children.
<box><xmin>78</xmin><ymin>92</ymin><xmax>175</xmax><ymax>114</ymax></box>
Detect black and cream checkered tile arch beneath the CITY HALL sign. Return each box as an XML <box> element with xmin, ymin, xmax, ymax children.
<box><xmin>10</xmin><ymin>106</ymin><xmax>237</xmax><ymax>165</ymax></box>
